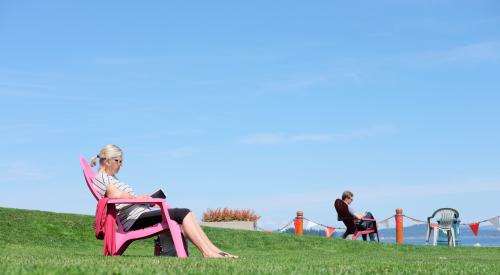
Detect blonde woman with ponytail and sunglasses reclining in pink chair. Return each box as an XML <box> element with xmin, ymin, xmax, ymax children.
<box><xmin>90</xmin><ymin>145</ymin><xmax>238</xmax><ymax>258</ymax></box>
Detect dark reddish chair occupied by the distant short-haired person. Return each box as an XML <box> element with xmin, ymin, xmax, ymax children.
<box><xmin>335</xmin><ymin>199</ymin><xmax>380</xmax><ymax>242</ymax></box>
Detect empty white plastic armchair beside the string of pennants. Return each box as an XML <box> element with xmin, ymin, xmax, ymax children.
<box><xmin>426</xmin><ymin>208</ymin><xmax>459</xmax><ymax>246</ymax></box>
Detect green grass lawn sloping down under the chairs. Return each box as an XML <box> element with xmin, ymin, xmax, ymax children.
<box><xmin>0</xmin><ymin>208</ymin><xmax>500</xmax><ymax>274</ymax></box>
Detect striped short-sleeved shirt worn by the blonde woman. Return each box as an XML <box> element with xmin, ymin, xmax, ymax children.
<box><xmin>94</xmin><ymin>172</ymin><xmax>151</xmax><ymax>230</ymax></box>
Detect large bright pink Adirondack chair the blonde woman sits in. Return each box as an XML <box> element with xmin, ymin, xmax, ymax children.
<box><xmin>80</xmin><ymin>157</ymin><xmax>188</xmax><ymax>258</ymax></box>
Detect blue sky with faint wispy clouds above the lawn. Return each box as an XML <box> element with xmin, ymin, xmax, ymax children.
<box><xmin>0</xmin><ymin>0</ymin><xmax>500</xmax><ymax>229</ymax></box>
